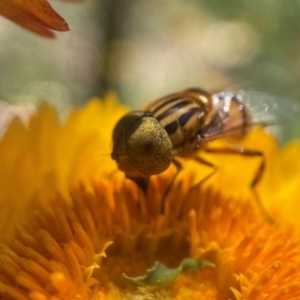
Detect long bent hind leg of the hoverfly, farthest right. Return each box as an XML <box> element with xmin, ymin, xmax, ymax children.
<box><xmin>205</xmin><ymin>147</ymin><xmax>275</xmax><ymax>224</ymax></box>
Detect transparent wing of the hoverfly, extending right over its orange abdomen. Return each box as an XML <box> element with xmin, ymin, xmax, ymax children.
<box><xmin>203</xmin><ymin>90</ymin><xmax>299</xmax><ymax>140</ymax></box>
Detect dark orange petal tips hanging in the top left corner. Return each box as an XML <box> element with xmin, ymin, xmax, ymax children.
<box><xmin>0</xmin><ymin>0</ymin><xmax>69</xmax><ymax>38</ymax></box>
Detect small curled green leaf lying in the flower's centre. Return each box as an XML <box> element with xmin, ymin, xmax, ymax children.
<box><xmin>123</xmin><ymin>258</ymin><xmax>215</xmax><ymax>286</ymax></box>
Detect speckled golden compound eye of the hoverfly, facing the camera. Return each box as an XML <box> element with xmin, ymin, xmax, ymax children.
<box><xmin>125</xmin><ymin>116</ymin><xmax>173</xmax><ymax>176</ymax></box>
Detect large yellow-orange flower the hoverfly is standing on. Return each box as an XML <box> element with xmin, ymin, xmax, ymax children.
<box><xmin>0</xmin><ymin>94</ymin><xmax>300</xmax><ymax>300</ymax></box>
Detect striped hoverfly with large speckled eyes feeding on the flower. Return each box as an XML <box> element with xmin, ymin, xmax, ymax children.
<box><xmin>111</xmin><ymin>88</ymin><xmax>298</xmax><ymax>219</ymax></box>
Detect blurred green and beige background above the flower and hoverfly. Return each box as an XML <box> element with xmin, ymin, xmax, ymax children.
<box><xmin>0</xmin><ymin>0</ymin><xmax>300</xmax><ymax>139</ymax></box>
